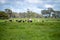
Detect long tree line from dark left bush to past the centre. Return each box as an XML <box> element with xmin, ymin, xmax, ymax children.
<box><xmin>0</xmin><ymin>9</ymin><xmax>42</xmax><ymax>19</ymax></box>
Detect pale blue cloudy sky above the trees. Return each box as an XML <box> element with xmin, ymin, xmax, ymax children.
<box><xmin>0</xmin><ymin>0</ymin><xmax>60</xmax><ymax>13</ymax></box>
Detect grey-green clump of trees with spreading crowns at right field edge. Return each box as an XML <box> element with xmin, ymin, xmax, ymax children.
<box><xmin>41</xmin><ymin>8</ymin><xmax>60</xmax><ymax>18</ymax></box>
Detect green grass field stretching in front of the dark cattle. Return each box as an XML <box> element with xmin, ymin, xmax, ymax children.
<box><xmin>0</xmin><ymin>19</ymin><xmax>60</xmax><ymax>40</ymax></box>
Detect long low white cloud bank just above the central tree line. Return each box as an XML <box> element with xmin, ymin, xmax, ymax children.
<box><xmin>10</xmin><ymin>6</ymin><xmax>43</xmax><ymax>14</ymax></box>
